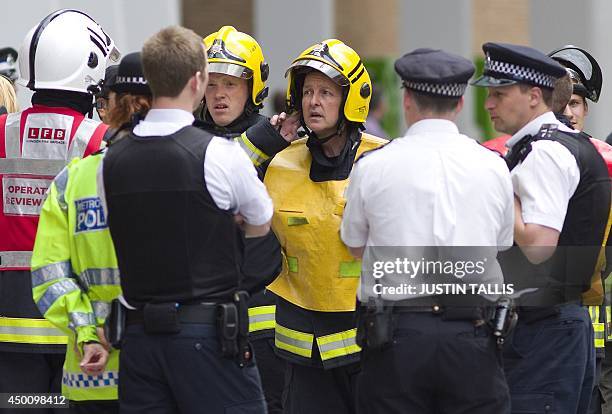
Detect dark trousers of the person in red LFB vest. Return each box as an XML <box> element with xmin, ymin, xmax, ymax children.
<box><xmin>0</xmin><ymin>352</ymin><xmax>68</xmax><ymax>414</ymax></box>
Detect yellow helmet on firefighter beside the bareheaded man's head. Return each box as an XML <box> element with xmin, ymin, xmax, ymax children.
<box><xmin>204</xmin><ymin>26</ymin><xmax>270</xmax><ymax>107</ymax></box>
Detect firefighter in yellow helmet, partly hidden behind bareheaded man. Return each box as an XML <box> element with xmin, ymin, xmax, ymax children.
<box><xmin>196</xmin><ymin>26</ymin><xmax>299</xmax><ymax>413</ymax></box>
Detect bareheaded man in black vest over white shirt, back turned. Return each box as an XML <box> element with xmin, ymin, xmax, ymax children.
<box><xmin>102</xmin><ymin>27</ymin><xmax>272</xmax><ymax>413</ymax></box>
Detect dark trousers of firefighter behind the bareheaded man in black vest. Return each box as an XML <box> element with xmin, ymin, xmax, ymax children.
<box><xmin>251</xmin><ymin>338</ymin><xmax>287</xmax><ymax>414</ymax></box>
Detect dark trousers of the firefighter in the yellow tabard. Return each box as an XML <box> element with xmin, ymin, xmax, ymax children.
<box><xmin>283</xmin><ymin>362</ymin><xmax>361</xmax><ymax>414</ymax></box>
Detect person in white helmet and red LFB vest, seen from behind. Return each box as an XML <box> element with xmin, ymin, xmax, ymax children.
<box><xmin>0</xmin><ymin>10</ymin><xmax>119</xmax><ymax>408</ymax></box>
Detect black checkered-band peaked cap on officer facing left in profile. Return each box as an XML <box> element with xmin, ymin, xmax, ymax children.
<box><xmin>472</xmin><ymin>42</ymin><xmax>566</xmax><ymax>89</ymax></box>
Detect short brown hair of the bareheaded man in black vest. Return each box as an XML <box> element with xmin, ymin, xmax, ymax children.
<box><xmin>142</xmin><ymin>26</ymin><xmax>206</xmax><ymax>98</ymax></box>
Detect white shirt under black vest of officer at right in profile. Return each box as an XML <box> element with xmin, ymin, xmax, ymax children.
<box><xmin>506</xmin><ymin>112</ymin><xmax>580</xmax><ymax>232</ymax></box>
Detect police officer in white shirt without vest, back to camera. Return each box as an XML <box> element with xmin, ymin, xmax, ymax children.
<box><xmin>341</xmin><ymin>49</ymin><xmax>513</xmax><ymax>414</ymax></box>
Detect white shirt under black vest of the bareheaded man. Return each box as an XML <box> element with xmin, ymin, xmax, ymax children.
<box><xmin>106</xmin><ymin>109</ymin><xmax>273</xmax><ymax>226</ymax></box>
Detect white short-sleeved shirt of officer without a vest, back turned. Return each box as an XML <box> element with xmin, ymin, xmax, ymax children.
<box><xmin>341</xmin><ymin>119</ymin><xmax>514</xmax><ymax>300</ymax></box>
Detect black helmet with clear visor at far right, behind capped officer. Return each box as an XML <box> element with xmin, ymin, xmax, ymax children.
<box><xmin>548</xmin><ymin>45</ymin><xmax>603</xmax><ymax>102</ymax></box>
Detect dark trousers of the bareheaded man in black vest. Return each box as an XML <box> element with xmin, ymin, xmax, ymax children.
<box><xmin>119</xmin><ymin>324</ymin><xmax>266</xmax><ymax>414</ymax></box>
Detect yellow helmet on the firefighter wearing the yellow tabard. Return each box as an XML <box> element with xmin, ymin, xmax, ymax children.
<box><xmin>285</xmin><ymin>39</ymin><xmax>372</xmax><ymax>123</ymax></box>
